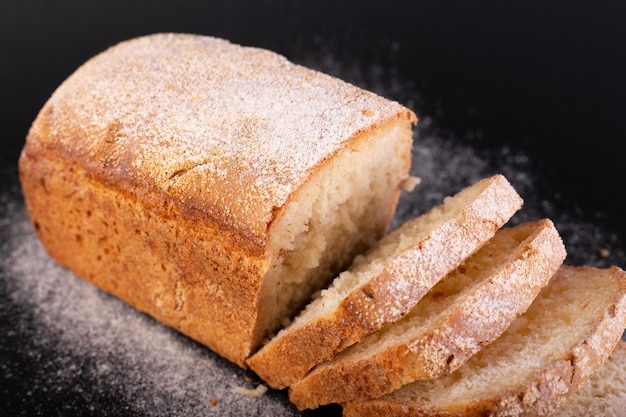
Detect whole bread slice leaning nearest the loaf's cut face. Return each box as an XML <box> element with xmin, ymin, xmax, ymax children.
<box><xmin>247</xmin><ymin>175</ymin><xmax>522</xmax><ymax>389</ymax></box>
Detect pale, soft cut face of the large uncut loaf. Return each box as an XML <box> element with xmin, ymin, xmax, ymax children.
<box><xmin>255</xmin><ymin>121</ymin><xmax>412</xmax><ymax>344</ymax></box>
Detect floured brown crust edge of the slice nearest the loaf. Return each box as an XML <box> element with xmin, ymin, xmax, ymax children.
<box><xmin>248</xmin><ymin>175</ymin><xmax>522</xmax><ymax>389</ymax></box>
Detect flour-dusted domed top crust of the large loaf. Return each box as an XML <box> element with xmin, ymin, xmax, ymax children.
<box><xmin>28</xmin><ymin>33</ymin><xmax>416</xmax><ymax>250</ymax></box>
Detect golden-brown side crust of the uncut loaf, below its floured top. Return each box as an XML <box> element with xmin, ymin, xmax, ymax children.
<box><xmin>21</xmin><ymin>153</ymin><xmax>266</xmax><ymax>362</ymax></box>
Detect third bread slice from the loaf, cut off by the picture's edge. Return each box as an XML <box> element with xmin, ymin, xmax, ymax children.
<box><xmin>343</xmin><ymin>265</ymin><xmax>626</xmax><ymax>417</ymax></box>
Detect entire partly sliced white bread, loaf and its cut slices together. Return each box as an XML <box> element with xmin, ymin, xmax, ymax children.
<box><xmin>19</xmin><ymin>33</ymin><xmax>626</xmax><ymax>417</ymax></box>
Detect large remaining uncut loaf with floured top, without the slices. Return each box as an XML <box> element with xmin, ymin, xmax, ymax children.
<box><xmin>19</xmin><ymin>34</ymin><xmax>417</xmax><ymax>366</ymax></box>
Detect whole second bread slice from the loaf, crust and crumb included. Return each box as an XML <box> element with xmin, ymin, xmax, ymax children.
<box><xmin>289</xmin><ymin>219</ymin><xmax>566</xmax><ymax>410</ymax></box>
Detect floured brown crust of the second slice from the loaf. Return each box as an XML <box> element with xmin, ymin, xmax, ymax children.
<box><xmin>289</xmin><ymin>219</ymin><xmax>566</xmax><ymax>410</ymax></box>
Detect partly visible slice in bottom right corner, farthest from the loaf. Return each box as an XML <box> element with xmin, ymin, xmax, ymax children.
<box><xmin>550</xmin><ymin>340</ymin><xmax>626</xmax><ymax>417</ymax></box>
